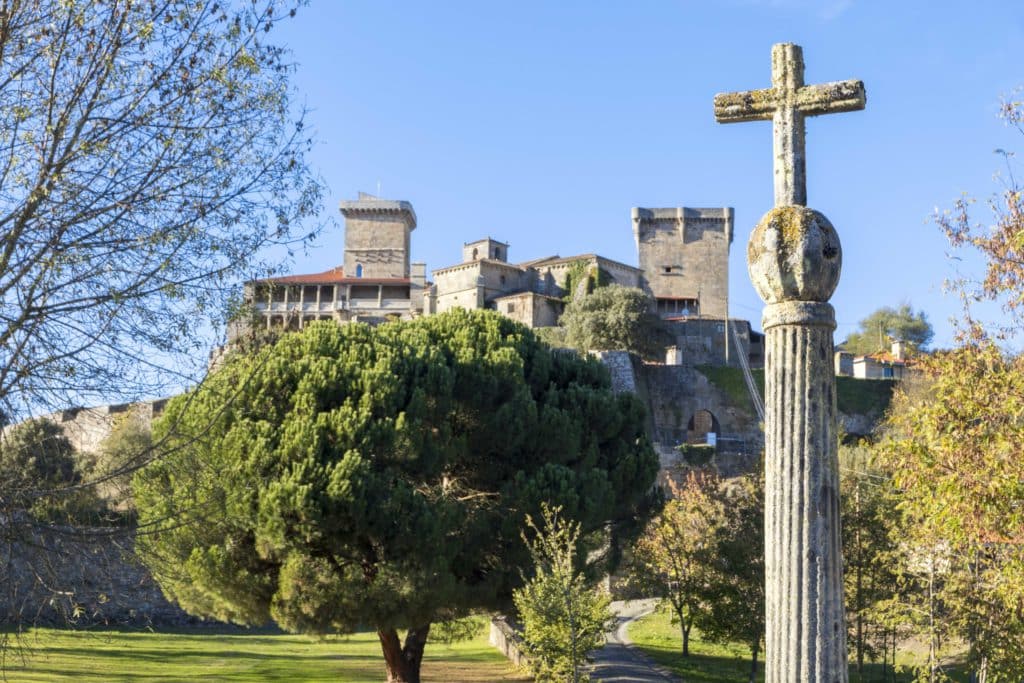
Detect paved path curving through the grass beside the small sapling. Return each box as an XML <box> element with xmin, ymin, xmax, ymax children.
<box><xmin>591</xmin><ymin>600</ymin><xmax>680</xmax><ymax>683</ymax></box>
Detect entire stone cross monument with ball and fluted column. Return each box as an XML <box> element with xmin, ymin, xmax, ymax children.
<box><xmin>715</xmin><ymin>44</ymin><xmax>864</xmax><ymax>683</ymax></box>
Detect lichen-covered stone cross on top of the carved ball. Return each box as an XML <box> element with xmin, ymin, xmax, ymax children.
<box><xmin>715</xmin><ymin>43</ymin><xmax>866</xmax><ymax>207</ymax></box>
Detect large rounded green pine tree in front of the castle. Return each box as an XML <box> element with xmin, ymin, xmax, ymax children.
<box><xmin>135</xmin><ymin>310</ymin><xmax>657</xmax><ymax>680</ymax></box>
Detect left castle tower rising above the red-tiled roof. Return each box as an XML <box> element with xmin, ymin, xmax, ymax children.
<box><xmin>341</xmin><ymin>193</ymin><xmax>416</xmax><ymax>280</ymax></box>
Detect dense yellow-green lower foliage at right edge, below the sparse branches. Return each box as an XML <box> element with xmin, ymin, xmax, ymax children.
<box><xmin>876</xmin><ymin>344</ymin><xmax>1024</xmax><ymax>682</ymax></box>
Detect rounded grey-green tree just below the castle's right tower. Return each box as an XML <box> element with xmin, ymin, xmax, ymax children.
<box><xmin>559</xmin><ymin>285</ymin><xmax>669</xmax><ymax>357</ymax></box>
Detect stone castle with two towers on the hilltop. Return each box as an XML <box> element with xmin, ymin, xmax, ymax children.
<box><xmin>229</xmin><ymin>193</ymin><xmax>761</xmax><ymax>374</ymax></box>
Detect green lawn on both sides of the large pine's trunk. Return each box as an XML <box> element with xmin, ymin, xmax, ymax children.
<box><xmin>4</xmin><ymin>629</ymin><xmax>530</xmax><ymax>683</ymax></box>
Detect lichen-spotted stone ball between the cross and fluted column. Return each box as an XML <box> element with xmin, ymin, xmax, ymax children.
<box><xmin>746</xmin><ymin>206</ymin><xmax>843</xmax><ymax>304</ymax></box>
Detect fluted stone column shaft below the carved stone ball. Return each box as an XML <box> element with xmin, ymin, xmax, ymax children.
<box><xmin>764</xmin><ymin>302</ymin><xmax>847</xmax><ymax>683</ymax></box>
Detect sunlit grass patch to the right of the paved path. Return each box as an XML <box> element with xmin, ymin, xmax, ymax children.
<box><xmin>629</xmin><ymin>610</ymin><xmax>967</xmax><ymax>683</ymax></box>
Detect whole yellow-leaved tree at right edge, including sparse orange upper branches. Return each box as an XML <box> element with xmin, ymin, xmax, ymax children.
<box><xmin>860</xmin><ymin>101</ymin><xmax>1024</xmax><ymax>683</ymax></box>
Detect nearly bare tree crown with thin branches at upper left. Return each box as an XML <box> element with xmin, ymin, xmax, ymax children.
<box><xmin>0</xmin><ymin>0</ymin><xmax>321</xmax><ymax>419</ymax></box>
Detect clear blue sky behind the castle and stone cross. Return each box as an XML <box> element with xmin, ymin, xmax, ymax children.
<box><xmin>276</xmin><ymin>0</ymin><xmax>1024</xmax><ymax>346</ymax></box>
